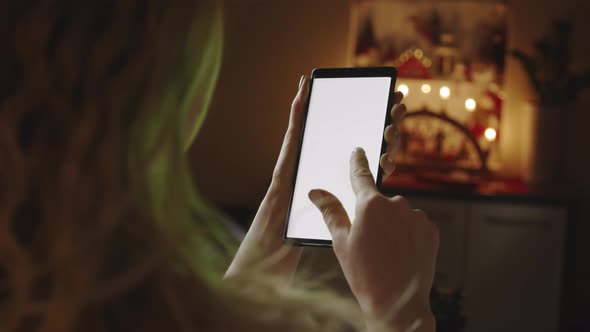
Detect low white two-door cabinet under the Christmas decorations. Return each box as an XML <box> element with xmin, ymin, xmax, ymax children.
<box><xmin>409</xmin><ymin>197</ymin><xmax>567</xmax><ymax>332</ymax></box>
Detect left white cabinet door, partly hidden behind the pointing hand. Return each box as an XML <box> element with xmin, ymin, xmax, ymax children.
<box><xmin>408</xmin><ymin>198</ymin><xmax>467</xmax><ymax>289</ymax></box>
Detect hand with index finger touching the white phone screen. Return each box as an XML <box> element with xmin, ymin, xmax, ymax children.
<box><xmin>309</xmin><ymin>148</ymin><xmax>438</xmax><ymax>331</ymax></box>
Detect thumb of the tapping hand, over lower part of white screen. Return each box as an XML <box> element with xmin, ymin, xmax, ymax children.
<box><xmin>308</xmin><ymin>189</ymin><xmax>350</xmax><ymax>250</ymax></box>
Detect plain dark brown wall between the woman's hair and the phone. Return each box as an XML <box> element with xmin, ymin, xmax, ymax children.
<box><xmin>190</xmin><ymin>0</ymin><xmax>349</xmax><ymax>207</ymax></box>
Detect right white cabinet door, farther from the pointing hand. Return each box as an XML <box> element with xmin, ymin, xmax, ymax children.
<box><xmin>464</xmin><ymin>203</ymin><xmax>567</xmax><ymax>332</ymax></box>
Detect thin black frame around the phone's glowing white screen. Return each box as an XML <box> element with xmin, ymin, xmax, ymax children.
<box><xmin>283</xmin><ymin>67</ymin><xmax>397</xmax><ymax>247</ymax></box>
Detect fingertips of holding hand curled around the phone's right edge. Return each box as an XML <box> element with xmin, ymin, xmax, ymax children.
<box><xmin>379</xmin><ymin>91</ymin><xmax>406</xmax><ymax>179</ymax></box>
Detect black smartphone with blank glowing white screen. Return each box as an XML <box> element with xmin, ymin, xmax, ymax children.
<box><xmin>284</xmin><ymin>67</ymin><xmax>396</xmax><ymax>246</ymax></box>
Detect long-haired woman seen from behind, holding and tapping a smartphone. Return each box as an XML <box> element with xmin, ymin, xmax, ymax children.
<box><xmin>0</xmin><ymin>0</ymin><xmax>438</xmax><ymax>332</ymax></box>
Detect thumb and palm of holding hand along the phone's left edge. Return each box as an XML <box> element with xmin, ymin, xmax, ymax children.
<box><xmin>226</xmin><ymin>76</ymin><xmax>309</xmax><ymax>279</ymax></box>
